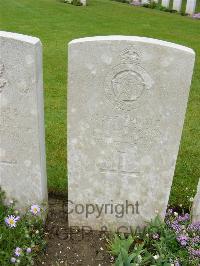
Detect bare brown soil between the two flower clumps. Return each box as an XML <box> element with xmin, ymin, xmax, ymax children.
<box><xmin>36</xmin><ymin>195</ymin><xmax>114</xmax><ymax>266</ymax></box>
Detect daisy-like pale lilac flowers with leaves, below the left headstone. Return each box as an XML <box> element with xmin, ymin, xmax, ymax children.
<box><xmin>0</xmin><ymin>189</ymin><xmax>46</xmax><ymax>266</ymax></box>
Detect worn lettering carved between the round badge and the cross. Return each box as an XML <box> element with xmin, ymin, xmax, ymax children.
<box><xmin>92</xmin><ymin>114</ymin><xmax>161</xmax><ymax>151</ymax></box>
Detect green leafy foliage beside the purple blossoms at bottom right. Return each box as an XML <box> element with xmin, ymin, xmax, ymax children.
<box><xmin>109</xmin><ymin>217</ymin><xmax>199</xmax><ymax>266</ymax></box>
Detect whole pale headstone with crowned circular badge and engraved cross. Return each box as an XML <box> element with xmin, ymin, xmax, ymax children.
<box><xmin>68</xmin><ymin>36</ymin><xmax>195</xmax><ymax>231</ymax></box>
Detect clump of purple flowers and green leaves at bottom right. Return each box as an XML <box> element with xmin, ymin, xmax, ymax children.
<box><xmin>109</xmin><ymin>209</ymin><xmax>200</xmax><ymax>266</ymax></box>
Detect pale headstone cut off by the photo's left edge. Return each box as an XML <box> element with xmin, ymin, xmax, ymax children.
<box><xmin>0</xmin><ymin>31</ymin><xmax>47</xmax><ymax>209</ymax></box>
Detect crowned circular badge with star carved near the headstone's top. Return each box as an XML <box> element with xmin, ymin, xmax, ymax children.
<box><xmin>105</xmin><ymin>46</ymin><xmax>152</xmax><ymax>111</ymax></box>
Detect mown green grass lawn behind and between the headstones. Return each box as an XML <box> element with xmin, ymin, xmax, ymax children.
<box><xmin>0</xmin><ymin>0</ymin><xmax>200</xmax><ymax>208</ymax></box>
